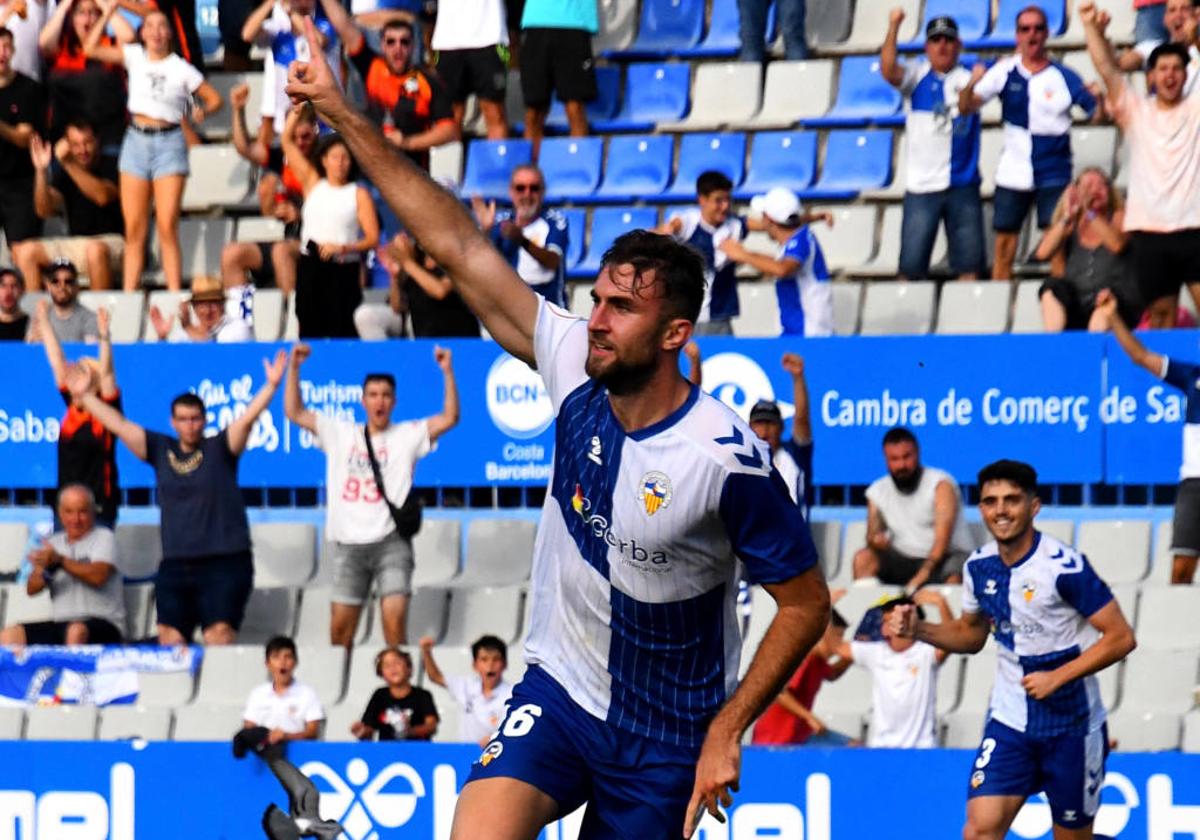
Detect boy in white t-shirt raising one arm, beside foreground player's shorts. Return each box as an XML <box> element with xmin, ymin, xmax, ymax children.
<box><xmin>421</xmin><ymin>636</ymin><xmax>512</xmax><ymax>746</ymax></box>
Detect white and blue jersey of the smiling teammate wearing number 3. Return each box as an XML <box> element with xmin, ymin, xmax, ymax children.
<box><xmin>962</xmin><ymin>532</ymin><xmax>1112</xmax><ymax>738</ymax></box>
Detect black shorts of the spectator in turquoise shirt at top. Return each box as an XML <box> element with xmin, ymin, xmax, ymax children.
<box><xmin>521</xmin><ymin>29</ymin><xmax>596</xmax><ymax>110</ymax></box>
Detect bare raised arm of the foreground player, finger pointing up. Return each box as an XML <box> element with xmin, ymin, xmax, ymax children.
<box><xmin>287</xmin><ymin>20</ymin><xmax>539</xmax><ymax>365</ymax></box>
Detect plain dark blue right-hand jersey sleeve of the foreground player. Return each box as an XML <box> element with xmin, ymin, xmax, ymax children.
<box><xmin>720</xmin><ymin>468</ymin><xmax>817</xmax><ymax>583</ymax></box>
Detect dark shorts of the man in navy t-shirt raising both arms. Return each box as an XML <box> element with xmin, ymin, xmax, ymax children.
<box><xmin>154</xmin><ymin>551</ymin><xmax>254</xmax><ymax>641</ymax></box>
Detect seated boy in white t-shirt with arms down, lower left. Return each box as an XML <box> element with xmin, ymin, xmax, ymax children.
<box><xmin>241</xmin><ymin>636</ymin><xmax>325</xmax><ymax>744</ymax></box>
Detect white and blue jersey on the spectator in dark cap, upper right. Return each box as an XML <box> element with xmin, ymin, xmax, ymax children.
<box><xmin>900</xmin><ymin>58</ymin><xmax>980</xmax><ymax>193</ymax></box>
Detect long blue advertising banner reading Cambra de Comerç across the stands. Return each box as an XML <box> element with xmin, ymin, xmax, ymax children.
<box><xmin>0</xmin><ymin>331</ymin><xmax>1200</xmax><ymax>487</ymax></box>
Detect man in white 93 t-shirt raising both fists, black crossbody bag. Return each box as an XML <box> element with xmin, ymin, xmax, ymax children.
<box><xmin>283</xmin><ymin>344</ymin><xmax>458</xmax><ymax>648</ymax></box>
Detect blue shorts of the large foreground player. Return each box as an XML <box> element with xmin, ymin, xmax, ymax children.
<box><xmin>467</xmin><ymin>666</ymin><xmax>700</xmax><ymax>840</ymax></box>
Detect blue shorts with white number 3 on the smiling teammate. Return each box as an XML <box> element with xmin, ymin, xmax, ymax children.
<box><xmin>967</xmin><ymin>719</ymin><xmax>1109</xmax><ymax>828</ymax></box>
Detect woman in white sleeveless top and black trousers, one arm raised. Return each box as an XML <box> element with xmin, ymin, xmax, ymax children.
<box><xmin>280</xmin><ymin>104</ymin><xmax>379</xmax><ymax>338</ymax></box>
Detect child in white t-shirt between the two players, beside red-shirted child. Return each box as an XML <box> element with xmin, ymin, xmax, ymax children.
<box><xmin>838</xmin><ymin>589</ymin><xmax>954</xmax><ymax>748</ymax></box>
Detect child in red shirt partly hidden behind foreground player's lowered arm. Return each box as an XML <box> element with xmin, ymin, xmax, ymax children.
<box><xmin>754</xmin><ymin>610</ymin><xmax>853</xmax><ymax>746</ymax></box>
